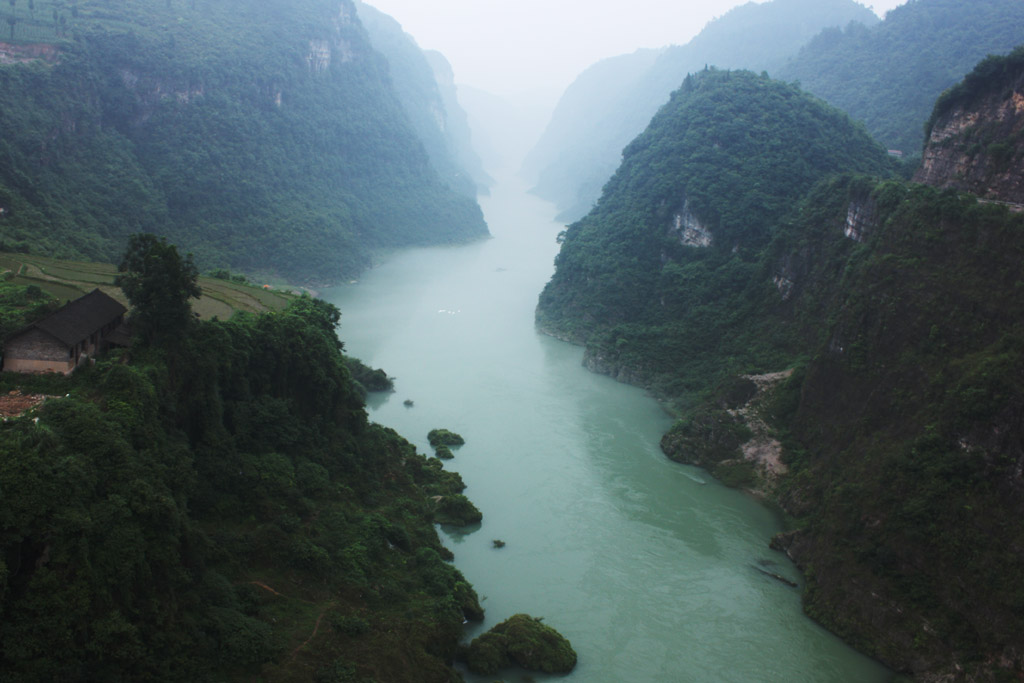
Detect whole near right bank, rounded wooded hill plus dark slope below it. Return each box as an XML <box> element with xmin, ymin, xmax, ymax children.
<box><xmin>538</xmin><ymin>53</ymin><xmax>1024</xmax><ymax>681</ymax></box>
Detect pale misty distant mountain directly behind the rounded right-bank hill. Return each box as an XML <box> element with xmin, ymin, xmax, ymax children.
<box><xmin>524</xmin><ymin>0</ymin><xmax>878</xmax><ymax>221</ymax></box>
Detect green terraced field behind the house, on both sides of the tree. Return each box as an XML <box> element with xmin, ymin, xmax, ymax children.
<box><xmin>0</xmin><ymin>252</ymin><xmax>295</xmax><ymax>318</ymax></box>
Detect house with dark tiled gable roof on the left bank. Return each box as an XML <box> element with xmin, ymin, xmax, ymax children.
<box><xmin>3</xmin><ymin>289</ymin><xmax>128</xmax><ymax>374</ymax></box>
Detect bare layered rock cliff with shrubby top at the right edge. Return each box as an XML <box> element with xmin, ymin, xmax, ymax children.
<box><xmin>914</xmin><ymin>54</ymin><xmax>1024</xmax><ymax>204</ymax></box>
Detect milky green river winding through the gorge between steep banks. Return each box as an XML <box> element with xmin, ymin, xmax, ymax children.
<box><xmin>323</xmin><ymin>181</ymin><xmax>891</xmax><ymax>683</ymax></box>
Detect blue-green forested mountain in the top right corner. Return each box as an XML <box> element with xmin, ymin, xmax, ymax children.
<box><xmin>775</xmin><ymin>0</ymin><xmax>1024</xmax><ymax>155</ymax></box>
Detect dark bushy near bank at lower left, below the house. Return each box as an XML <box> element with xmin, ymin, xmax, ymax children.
<box><xmin>0</xmin><ymin>244</ymin><xmax>482</xmax><ymax>682</ymax></box>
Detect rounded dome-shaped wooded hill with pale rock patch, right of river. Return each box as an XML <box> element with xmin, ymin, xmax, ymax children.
<box><xmin>537</xmin><ymin>70</ymin><xmax>890</xmax><ymax>396</ymax></box>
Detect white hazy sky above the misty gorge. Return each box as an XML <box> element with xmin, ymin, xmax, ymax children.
<box><xmin>365</xmin><ymin>0</ymin><xmax>905</xmax><ymax>96</ymax></box>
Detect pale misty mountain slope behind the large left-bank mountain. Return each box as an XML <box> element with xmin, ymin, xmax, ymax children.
<box><xmin>355</xmin><ymin>2</ymin><xmax>483</xmax><ymax>197</ymax></box>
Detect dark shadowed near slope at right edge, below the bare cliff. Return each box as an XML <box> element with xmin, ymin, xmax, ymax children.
<box><xmin>775</xmin><ymin>176</ymin><xmax>1024</xmax><ymax>680</ymax></box>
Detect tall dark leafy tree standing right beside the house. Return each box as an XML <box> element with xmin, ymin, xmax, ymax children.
<box><xmin>114</xmin><ymin>233</ymin><xmax>203</xmax><ymax>344</ymax></box>
